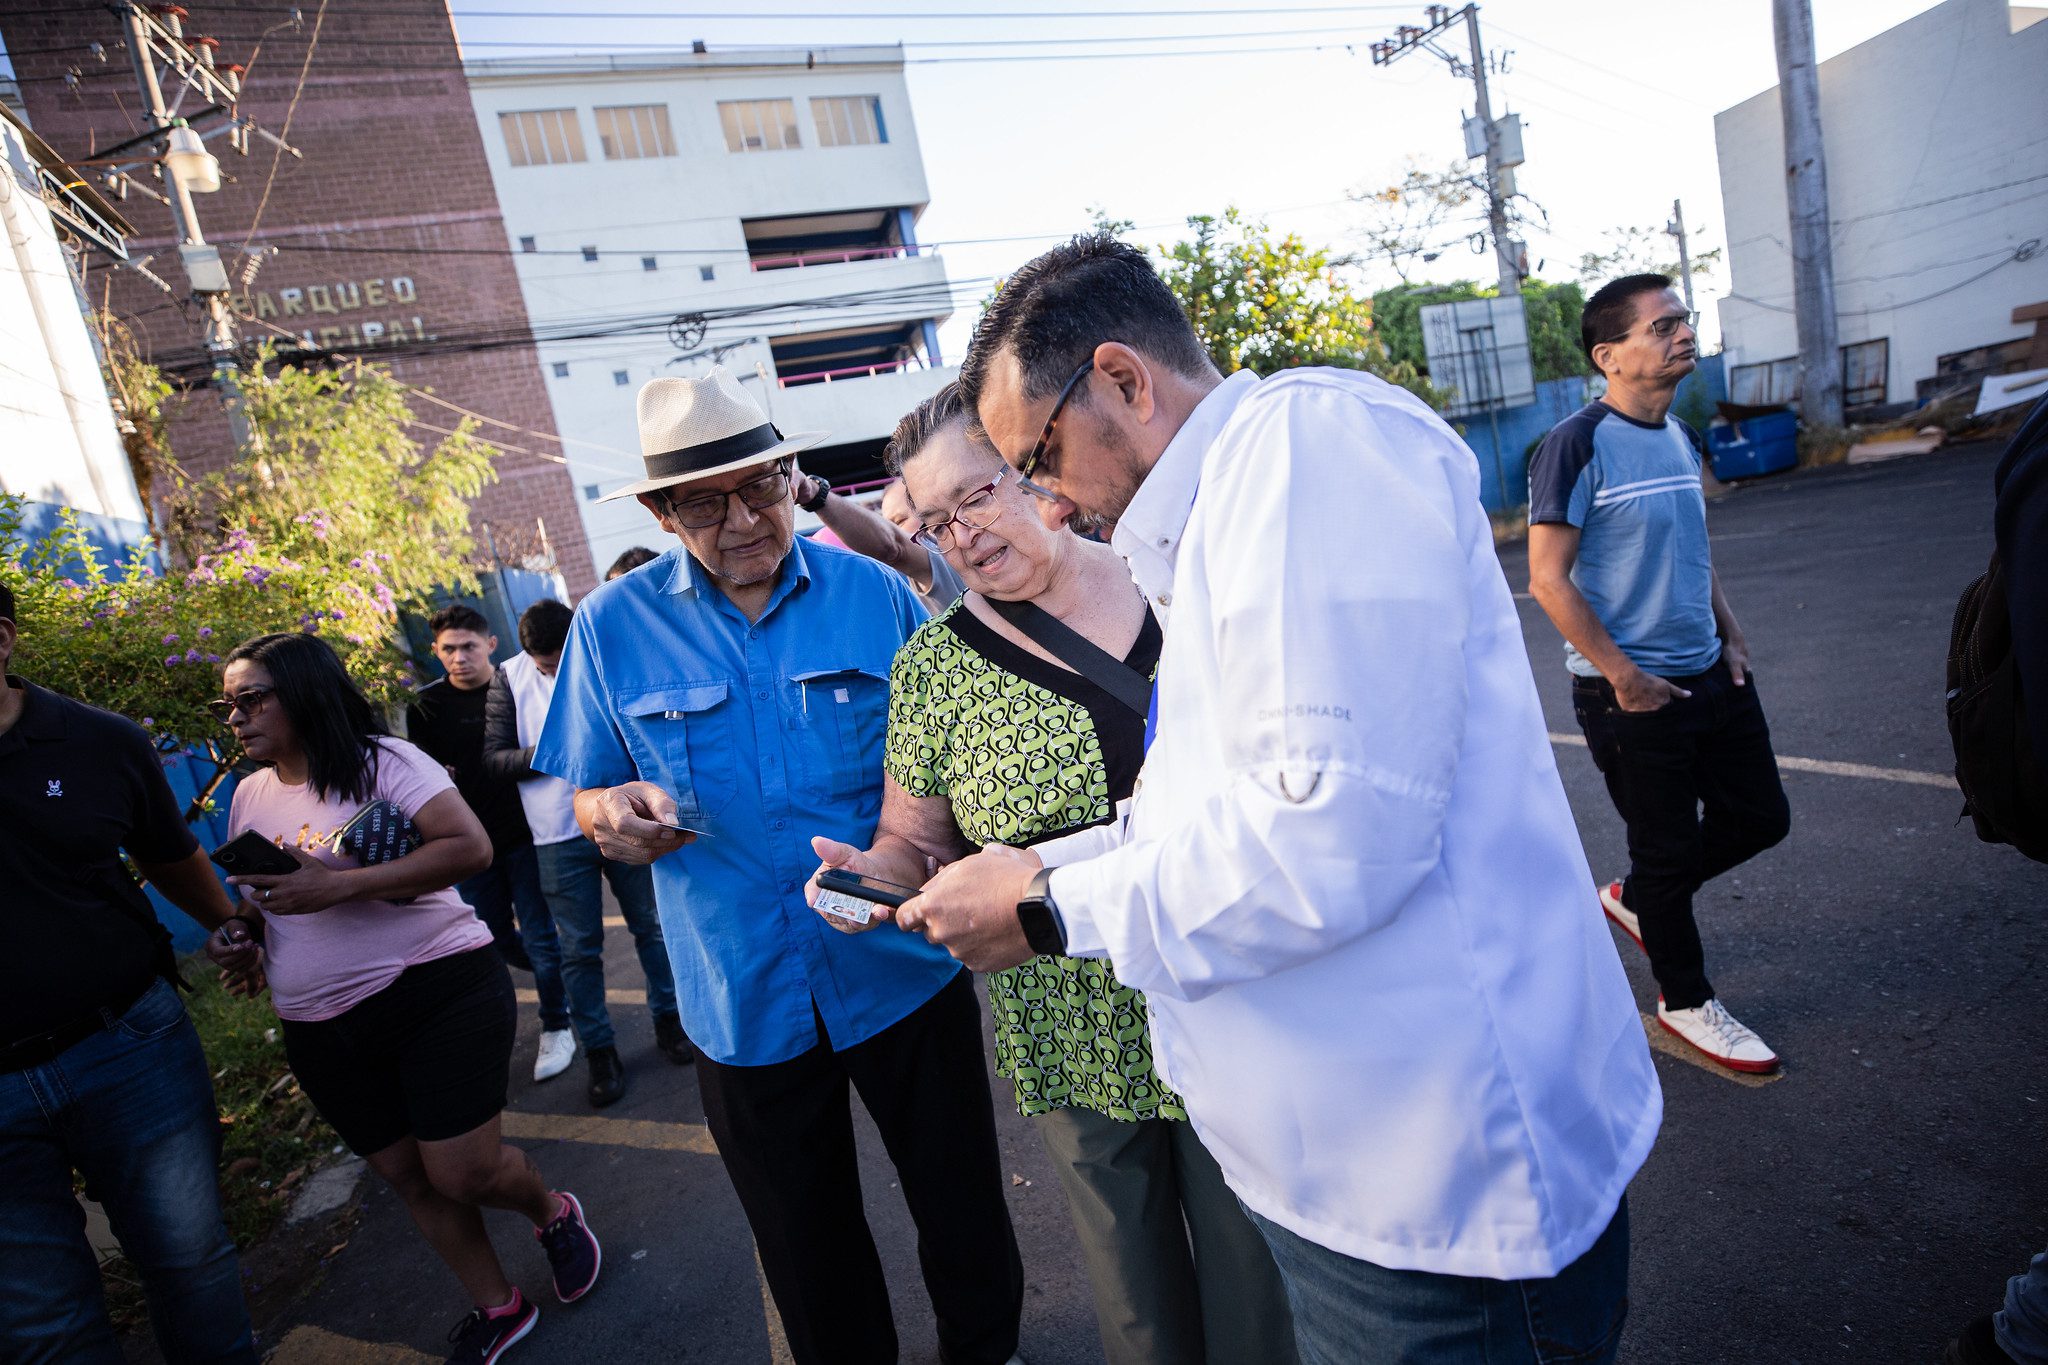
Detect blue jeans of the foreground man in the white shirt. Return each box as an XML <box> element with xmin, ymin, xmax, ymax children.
<box><xmin>1245</xmin><ymin>1197</ymin><xmax>1628</xmax><ymax>1365</ymax></box>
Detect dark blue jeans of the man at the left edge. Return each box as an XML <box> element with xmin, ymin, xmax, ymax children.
<box><xmin>0</xmin><ymin>980</ymin><xmax>256</xmax><ymax>1365</ymax></box>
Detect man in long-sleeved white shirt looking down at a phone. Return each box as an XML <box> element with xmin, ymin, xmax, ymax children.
<box><xmin>897</xmin><ymin>235</ymin><xmax>1663</xmax><ymax>1365</ymax></box>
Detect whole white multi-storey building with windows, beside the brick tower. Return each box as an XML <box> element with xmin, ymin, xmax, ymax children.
<box><xmin>465</xmin><ymin>47</ymin><xmax>952</xmax><ymax>569</ymax></box>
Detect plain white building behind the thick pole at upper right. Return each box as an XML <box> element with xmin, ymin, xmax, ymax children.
<box><xmin>1714</xmin><ymin>0</ymin><xmax>2048</xmax><ymax>409</ymax></box>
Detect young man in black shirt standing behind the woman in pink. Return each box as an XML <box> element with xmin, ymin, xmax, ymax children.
<box><xmin>406</xmin><ymin>604</ymin><xmax>575</xmax><ymax>1081</ymax></box>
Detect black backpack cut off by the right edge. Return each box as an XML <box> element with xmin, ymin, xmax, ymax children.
<box><xmin>1948</xmin><ymin>551</ymin><xmax>2048</xmax><ymax>864</ymax></box>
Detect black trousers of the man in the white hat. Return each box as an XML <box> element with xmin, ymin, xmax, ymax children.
<box><xmin>696</xmin><ymin>970</ymin><xmax>1024</xmax><ymax>1365</ymax></box>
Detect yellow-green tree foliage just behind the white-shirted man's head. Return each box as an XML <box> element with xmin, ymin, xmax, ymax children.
<box><xmin>1159</xmin><ymin>209</ymin><xmax>1440</xmax><ymax>403</ymax></box>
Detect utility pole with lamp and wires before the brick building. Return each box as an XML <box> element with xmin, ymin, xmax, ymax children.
<box><xmin>111</xmin><ymin>0</ymin><xmax>276</xmax><ymax>450</ymax></box>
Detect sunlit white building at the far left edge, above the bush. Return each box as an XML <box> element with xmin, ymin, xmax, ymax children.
<box><xmin>0</xmin><ymin>104</ymin><xmax>145</xmax><ymax>530</ymax></box>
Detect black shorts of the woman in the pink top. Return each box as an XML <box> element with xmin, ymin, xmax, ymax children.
<box><xmin>283</xmin><ymin>945</ymin><xmax>518</xmax><ymax>1156</ymax></box>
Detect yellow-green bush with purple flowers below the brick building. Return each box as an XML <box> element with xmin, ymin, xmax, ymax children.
<box><xmin>0</xmin><ymin>343</ymin><xmax>496</xmax><ymax>789</ymax></box>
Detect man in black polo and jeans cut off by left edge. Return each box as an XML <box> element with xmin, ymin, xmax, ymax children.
<box><xmin>0</xmin><ymin>585</ymin><xmax>256</xmax><ymax>1365</ymax></box>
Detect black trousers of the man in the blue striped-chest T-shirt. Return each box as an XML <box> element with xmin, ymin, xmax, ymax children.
<box><xmin>1571</xmin><ymin>661</ymin><xmax>1792</xmax><ymax>1009</ymax></box>
